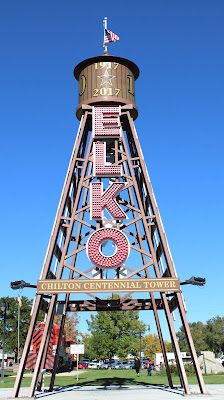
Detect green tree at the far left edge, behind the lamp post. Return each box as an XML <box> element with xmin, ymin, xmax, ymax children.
<box><xmin>0</xmin><ymin>296</ymin><xmax>32</xmax><ymax>352</ymax></box>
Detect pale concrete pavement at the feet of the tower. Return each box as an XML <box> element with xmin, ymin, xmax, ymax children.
<box><xmin>0</xmin><ymin>384</ymin><xmax>224</xmax><ymax>400</ymax></box>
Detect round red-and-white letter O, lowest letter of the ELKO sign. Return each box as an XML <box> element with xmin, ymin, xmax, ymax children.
<box><xmin>86</xmin><ymin>228</ymin><xmax>129</xmax><ymax>268</ymax></box>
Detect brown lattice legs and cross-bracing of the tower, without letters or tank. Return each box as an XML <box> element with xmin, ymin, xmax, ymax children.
<box><xmin>14</xmin><ymin>106</ymin><xmax>206</xmax><ymax>397</ymax></box>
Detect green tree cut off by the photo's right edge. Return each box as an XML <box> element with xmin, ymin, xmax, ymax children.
<box><xmin>206</xmin><ymin>316</ymin><xmax>224</xmax><ymax>355</ymax></box>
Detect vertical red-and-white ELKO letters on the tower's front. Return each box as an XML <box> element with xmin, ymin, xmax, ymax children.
<box><xmin>86</xmin><ymin>106</ymin><xmax>130</xmax><ymax>268</ymax></box>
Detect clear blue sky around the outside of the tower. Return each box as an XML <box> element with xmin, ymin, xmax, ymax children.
<box><xmin>0</xmin><ymin>0</ymin><xmax>224</xmax><ymax>340</ymax></box>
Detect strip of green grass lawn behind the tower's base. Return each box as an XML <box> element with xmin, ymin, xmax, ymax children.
<box><xmin>0</xmin><ymin>370</ymin><xmax>224</xmax><ymax>387</ymax></box>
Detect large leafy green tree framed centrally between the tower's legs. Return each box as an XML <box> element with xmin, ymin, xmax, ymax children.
<box><xmin>86</xmin><ymin>311</ymin><xmax>146</xmax><ymax>359</ymax></box>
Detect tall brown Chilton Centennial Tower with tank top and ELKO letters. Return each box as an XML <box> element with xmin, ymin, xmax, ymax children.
<box><xmin>13</xmin><ymin>53</ymin><xmax>206</xmax><ymax>397</ymax></box>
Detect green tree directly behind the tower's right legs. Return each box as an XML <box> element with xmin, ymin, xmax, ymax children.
<box><xmin>177</xmin><ymin>321</ymin><xmax>209</xmax><ymax>354</ymax></box>
